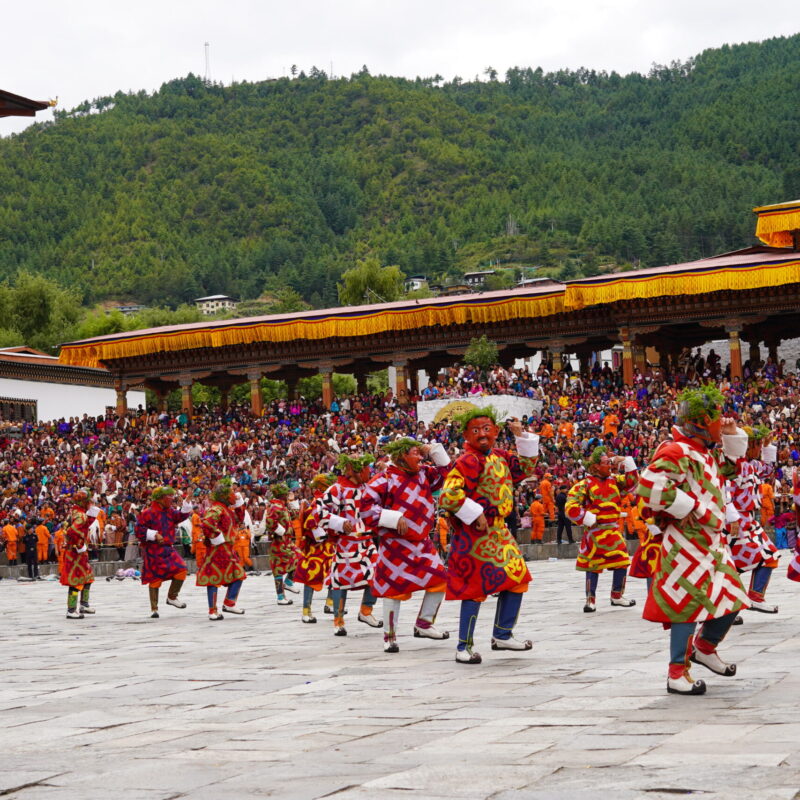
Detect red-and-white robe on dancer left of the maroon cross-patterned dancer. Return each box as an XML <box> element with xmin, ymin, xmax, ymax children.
<box><xmin>316</xmin><ymin>477</ymin><xmax>377</xmax><ymax>589</ymax></box>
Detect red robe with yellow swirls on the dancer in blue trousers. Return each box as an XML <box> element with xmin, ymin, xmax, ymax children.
<box><xmin>439</xmin><ymin>439</ymin><xmax>538</xmax><ymax>600</ymax></box>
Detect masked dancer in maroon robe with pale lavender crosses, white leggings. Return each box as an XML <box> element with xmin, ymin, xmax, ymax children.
<box><xmin>361</xmin><ymin>437</ymin><xmax>450</xmax><ymax>653</ymax></box>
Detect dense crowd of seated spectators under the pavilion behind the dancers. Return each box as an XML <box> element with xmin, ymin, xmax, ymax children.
<box><xmin>0</xmin><ymin>351</ymin><xmax>800</xmax><ymax>572</ymax></box>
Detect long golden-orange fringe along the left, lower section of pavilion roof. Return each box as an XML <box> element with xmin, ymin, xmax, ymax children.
<box><xmin>59</xmin><ymin>289</ymin><xmax>564</xmax><ymax>367</ymax></box>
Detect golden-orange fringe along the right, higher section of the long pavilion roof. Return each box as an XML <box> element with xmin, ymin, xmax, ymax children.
<box><xmin>564</xmin><ymin>258</ymin><xmax>800</xmax><ymax>311</ymax></box>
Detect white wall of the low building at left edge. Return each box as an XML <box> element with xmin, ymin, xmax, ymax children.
<box><xmin>0</xmin><ymin>378</ymin><xmax>145</xmax><ymax>422</ymax></box>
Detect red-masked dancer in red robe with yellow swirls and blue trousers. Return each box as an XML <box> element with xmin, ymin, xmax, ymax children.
<box><xmin>439</xmin><ymin>406</ymin><xmax>539</xmax><ymax>664</ymax></box>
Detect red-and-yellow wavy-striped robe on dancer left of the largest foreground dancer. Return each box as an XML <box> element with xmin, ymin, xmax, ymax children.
<box><xmin>564</xmin><ymin>459</ymin><xmax>639</xmax><ymax>572</ymax></box>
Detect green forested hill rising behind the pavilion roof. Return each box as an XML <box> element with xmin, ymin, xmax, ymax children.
<box><xmin>0</xmin><ymin>36</ymin><xmax>800</xmax><ymax>305</ymax></box>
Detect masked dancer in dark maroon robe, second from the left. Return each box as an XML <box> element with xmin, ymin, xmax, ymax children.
<box><xmin>134</xmin><ymin>486</ymin><xmax>193</xmax><ymax>619</ymax></box>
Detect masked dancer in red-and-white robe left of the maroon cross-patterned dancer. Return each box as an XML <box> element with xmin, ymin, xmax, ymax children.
<box><xmin>316</xmin><ymin>453</ymin><xmax>383</xmax><ymax>636</ymax></box>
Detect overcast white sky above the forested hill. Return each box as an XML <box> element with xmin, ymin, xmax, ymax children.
<box><xmin>0</xmin><ymin>0</ymin><xmax>800</xmax><ymax>135</ymax></box>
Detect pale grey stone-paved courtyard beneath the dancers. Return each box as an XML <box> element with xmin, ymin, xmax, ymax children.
<box><xmin>0</xmin><ymin>559</ymin><xmax>800</xmax><ymax>800</ymax></box>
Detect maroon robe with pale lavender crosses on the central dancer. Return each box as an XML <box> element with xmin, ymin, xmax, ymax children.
<box><xmin>361</xmin><ymin>464</ymin><xmax>449</xmax><ymax>599</ymax></box>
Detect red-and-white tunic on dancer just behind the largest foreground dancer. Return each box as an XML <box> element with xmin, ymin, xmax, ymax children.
<box><xmin>729</xmin><ymin>458</ymin><xmax>778</xmax><ymax>572</ymax></box>
